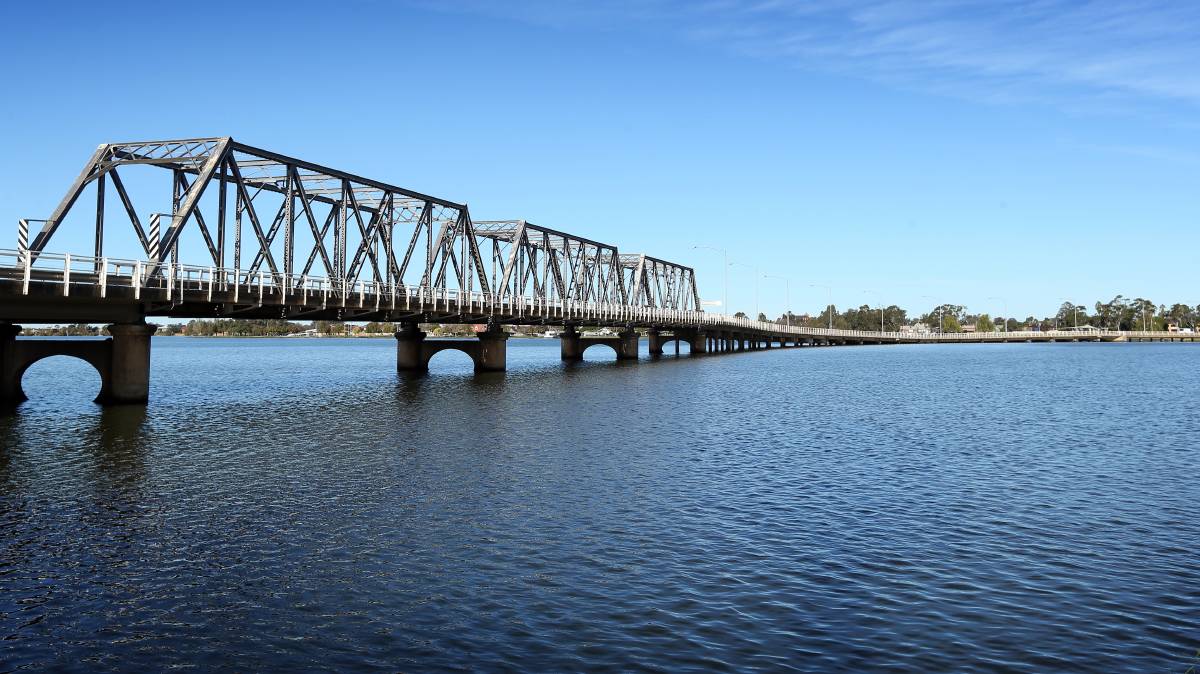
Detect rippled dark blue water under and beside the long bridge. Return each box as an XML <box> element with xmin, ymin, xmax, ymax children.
<box><xmin>0</xmin><ymin>338</ymin><xmax>1200</xmax><ymax>674</ymax></box>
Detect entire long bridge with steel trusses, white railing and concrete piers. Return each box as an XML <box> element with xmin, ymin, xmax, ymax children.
<box><xmin>0</xmin><ymin>137</ymin><xmax>1194</xmax><ymax>404</ymax></box>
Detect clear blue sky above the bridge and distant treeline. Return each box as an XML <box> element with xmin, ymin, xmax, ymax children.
<box><xmin>0</xmin><ymin>0</ymin><xmax>1200</xmax><ymax>317</ymax></box>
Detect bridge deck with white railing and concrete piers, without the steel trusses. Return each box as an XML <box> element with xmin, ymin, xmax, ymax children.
<box><xmin>0</xmin><ymin>251</ymin><xmax>1198</xmax><ymax>404</ymax></box>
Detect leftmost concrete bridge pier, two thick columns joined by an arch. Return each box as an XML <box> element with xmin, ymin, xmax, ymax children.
<box><xmin>0</xmin><ymin>323</ymin><xmax>156</xmax><ymax>407</ymax></box>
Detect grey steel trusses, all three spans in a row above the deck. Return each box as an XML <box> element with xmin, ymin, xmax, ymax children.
<box><xmin>18</xmin><ymin>137</ymin><xmax>700</xmax><ymax>311</ymax></box>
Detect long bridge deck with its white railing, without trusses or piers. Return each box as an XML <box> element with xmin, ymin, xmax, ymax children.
<box><xmin>0</xmin><ymin>251</ymin><xmax>1198</xmax><ymax>343</ymax></box>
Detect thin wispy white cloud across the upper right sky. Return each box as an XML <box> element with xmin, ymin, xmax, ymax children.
<box><xmin>419</xmin><ymin>0</ymin><xmax>1200</xmax><ymax>112</ymax></box>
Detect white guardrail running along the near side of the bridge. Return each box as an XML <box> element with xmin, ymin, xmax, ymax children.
<box><xmin>0</xmin><ymin>249</ymin><xmax>1200</xmax><ymax>342</ymax></box>
